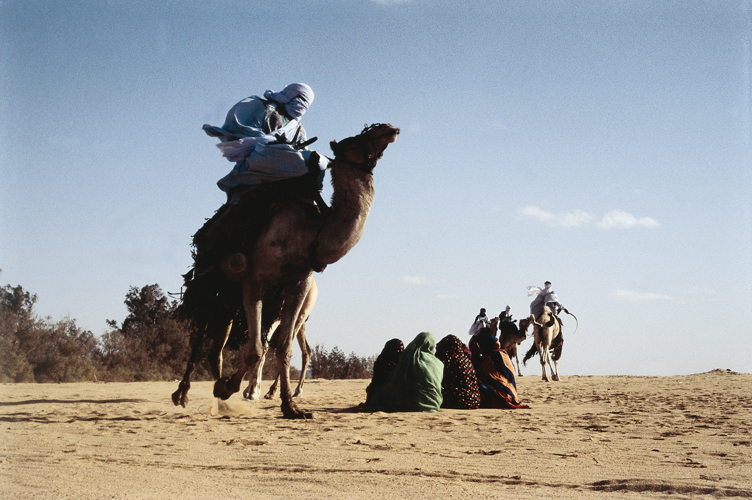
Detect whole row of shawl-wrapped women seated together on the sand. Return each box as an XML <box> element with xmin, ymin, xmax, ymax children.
<box><xmin>364</xmin><ymin>328</ymin><xmax>529</xmax><ymax>412</ymax></box>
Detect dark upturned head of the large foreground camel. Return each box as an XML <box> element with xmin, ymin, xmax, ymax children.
<box><xmin>329</xmin><ymin>123</ymin><xmax>400</xmax><ymax>173</ymax></box>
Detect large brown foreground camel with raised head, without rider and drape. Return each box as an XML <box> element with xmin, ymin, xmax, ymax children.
<box><xmin>213</xmin><ymin>124</ymin><xmax>399</xmax><ymax>418</ymax></box>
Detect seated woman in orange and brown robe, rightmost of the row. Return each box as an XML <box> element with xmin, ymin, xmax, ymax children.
<box><xmin>470</xmin><ymin>328</ymin><xmax>530</xmax><ymax>409</ymax></box>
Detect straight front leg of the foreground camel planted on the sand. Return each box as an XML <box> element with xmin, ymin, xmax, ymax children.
<box><xmin>276</xmin><ymin>275</ymin><xmax>313</xmax><ymax>418</ymax></box>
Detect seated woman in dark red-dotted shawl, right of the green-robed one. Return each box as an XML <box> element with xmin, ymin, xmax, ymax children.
<box><xmin>436</xmin><ymin>335</ymin><xmax>480</xmax><ymax>410</ymax></box>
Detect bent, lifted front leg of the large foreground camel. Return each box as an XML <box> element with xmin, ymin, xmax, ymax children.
<box><xmin>214</xmin><ymin>278</ymin><xmax>264</xmax><ymax>400</ymax></box>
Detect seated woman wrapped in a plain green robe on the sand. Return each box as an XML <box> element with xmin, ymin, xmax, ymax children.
<box><xmin>367</xmin><ymin>332</ymin><xmax>444</xmax><ymax>412</ymax></box>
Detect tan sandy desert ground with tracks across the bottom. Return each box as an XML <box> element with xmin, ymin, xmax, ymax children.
<box><xmin>0</xmin><ymin>367</ymin><xmax>752</xmax><ymax>500</ymax></box>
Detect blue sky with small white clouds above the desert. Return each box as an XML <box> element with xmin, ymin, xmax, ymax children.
<box><xmin>0</xmin><ymin>0</ymin><xmax>752</xmax><ymax>376</ymax></box>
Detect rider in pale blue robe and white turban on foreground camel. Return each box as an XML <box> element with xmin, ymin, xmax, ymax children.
<box><xmin>203</xmin><ymin>83</ymin><xmax>329</xmax><ymax>205</ymax></box>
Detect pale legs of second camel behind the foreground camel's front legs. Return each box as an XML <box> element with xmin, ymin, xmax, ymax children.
<box><xmin>243</xmin><ymin>280</ymin><xmax>319</xmax><ymax>401</ymax></box>
